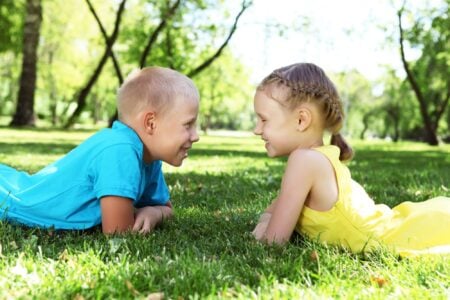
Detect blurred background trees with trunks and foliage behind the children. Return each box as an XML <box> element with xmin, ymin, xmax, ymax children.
<box><xmin>0</xmin><ymin>0</ymin><xmax>450</xmax><ymax>144</ymax></box>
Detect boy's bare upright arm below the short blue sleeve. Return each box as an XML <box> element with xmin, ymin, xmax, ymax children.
<box><xmin>100</xmin><ymin>196</ymin><xmax>134</xmax><ymax>234</ymax></box>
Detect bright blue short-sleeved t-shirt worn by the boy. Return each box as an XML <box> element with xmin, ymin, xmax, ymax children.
<box><xmin>0</xmin><ymin>121</ymin><xmax>170</xmax><ymax>229</ymax></box>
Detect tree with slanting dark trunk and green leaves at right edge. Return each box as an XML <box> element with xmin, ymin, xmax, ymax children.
<box><xmin>397</xmin><ymin>1</ymin><xmax>450</xmax><ymax>145</ymax></box>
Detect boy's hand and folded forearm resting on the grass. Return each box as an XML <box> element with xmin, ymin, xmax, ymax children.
<box><xmin>133</xmin><ymin>206</ymin><xmax>172</xmax><ymax>233</ymax></box>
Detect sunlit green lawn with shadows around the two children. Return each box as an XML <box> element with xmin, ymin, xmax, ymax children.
<box><xmin>0</xmin><ymin>128</ymin><xmax>450</xmax><ymax>299</ymax></box>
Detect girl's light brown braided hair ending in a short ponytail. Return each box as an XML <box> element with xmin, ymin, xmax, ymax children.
<box><xmin>258</xmin><ymin>63</ymin><xmax>353</xmax><ymax>160</ymax></box>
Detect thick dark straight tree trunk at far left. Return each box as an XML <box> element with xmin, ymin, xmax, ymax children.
<box><xmin>10</xmin><ymin>0</ymin><xmax>42</xmax><ymax>126</ymax></box>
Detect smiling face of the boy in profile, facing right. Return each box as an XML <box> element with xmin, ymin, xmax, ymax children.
<box><xmin>146</xmin><ymin>99</ymin><xmax>199</xmax><ymax>166</ymax></box>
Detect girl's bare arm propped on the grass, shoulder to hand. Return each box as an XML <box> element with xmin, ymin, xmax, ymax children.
<box><xmin>260</xmin><ymin>150</ymin><xmax>321</xmax><ymax>244</ymax></box>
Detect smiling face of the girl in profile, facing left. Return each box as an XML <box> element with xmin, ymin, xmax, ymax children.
<box><xmin>253</xmin><ymin>91</ymin><xmax>300</xmax><ymax>157</ymax></box>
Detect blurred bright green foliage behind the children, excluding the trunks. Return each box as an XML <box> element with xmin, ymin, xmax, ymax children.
<box><xmin>0</xmin><ymin>0</ymin><xmax>450</xmax><ymax>136</ymax></box>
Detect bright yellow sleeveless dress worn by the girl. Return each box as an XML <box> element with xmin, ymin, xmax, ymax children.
<box><xmin>296</xmin><ymin>146</ymin><xmax>450</xmax><ymax>256</ymax></box>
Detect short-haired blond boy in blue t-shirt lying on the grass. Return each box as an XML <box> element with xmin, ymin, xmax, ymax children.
<box><xmin>0</xmin><ymin>67</ymin><xmax>199</xmax><ymax>234</ymax></box>
